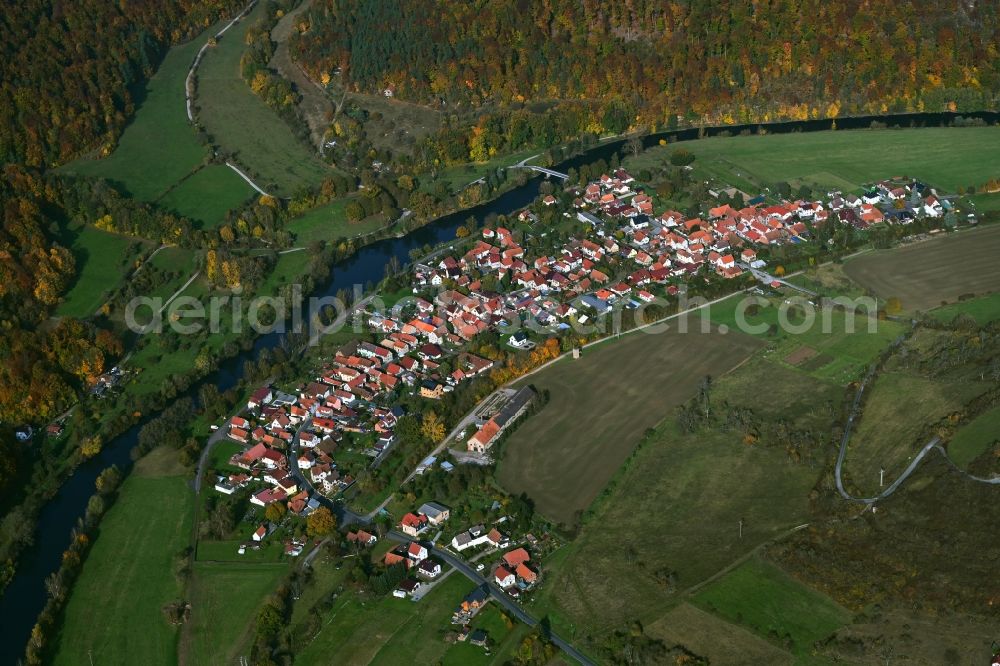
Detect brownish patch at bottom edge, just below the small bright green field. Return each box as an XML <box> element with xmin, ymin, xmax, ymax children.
<box><xmin>646</xmin><ymin>603</ymin><xmax>793</xmax><ymax>666</ymax></box>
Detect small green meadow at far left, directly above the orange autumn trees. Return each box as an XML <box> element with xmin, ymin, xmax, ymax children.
<box><xmin>56</xmin><ymin>226</ymin><xmax>152</xmax><ymax>317</ymax></box>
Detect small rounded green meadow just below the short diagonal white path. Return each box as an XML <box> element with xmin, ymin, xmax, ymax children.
<box><xmin>157</xmin><ymin>164</ymin><xmax>256</xmax><ymax>229</ymax></box>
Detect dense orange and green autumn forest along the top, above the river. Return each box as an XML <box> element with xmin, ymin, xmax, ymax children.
<box><xmin>291</xmin><ymin>0</ymin><xmax>1000</xmax><ymax>133</ymax></box>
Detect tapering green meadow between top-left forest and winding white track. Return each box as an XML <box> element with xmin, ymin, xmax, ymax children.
<box><xmin>64</xmin><ymin>28</ymin><xmax>217</xmax><ymax>201</ymax></box>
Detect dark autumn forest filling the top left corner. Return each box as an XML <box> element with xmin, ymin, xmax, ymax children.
<box><xmin>0</xmin><ymin>0</ymin><xmax>242</xmax><ymax>167</ymax></box>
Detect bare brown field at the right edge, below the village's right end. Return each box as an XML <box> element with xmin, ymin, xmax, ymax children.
<box><xmin>844</xmin><ymin>226</ymin><xmax>1000</xmax><ymax>312</ymax></box>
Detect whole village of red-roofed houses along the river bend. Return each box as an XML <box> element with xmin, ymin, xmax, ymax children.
<box><xmin>203</xmin><ymin>169</ymin><xmax>948</xmax><ymax>646</ymax></box>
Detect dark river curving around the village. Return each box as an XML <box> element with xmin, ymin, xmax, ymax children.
<box><xmin>0</xmin><ymin>112</ymin><xmax>1000</xmax><ymax>664</ymax></box>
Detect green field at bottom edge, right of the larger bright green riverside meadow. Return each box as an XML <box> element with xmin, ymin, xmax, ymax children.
<box><xmin>180</xmin><ymin>562</ymin><xmax>288</xmax><ymax>664</ymax></box>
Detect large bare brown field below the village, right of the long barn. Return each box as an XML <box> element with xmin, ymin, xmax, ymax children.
<box><xmin>499</xmin><ymin>324</ymin><xmax>760</xmax><ymax>524</ymax></box>
